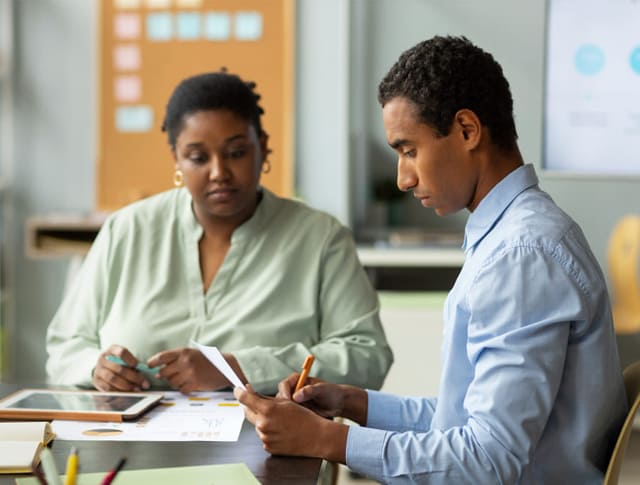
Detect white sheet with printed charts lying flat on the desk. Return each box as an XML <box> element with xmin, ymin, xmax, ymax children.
<box><xmin>51</xmin><ymin>391</ymin><xmax>244</xmax><ymax>441</ymax></box>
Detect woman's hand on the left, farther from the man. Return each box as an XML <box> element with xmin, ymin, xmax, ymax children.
<box><xmin>92</xmin><ymin>345</ymin><xmax>150</xmax><ymax>392</ymax></box>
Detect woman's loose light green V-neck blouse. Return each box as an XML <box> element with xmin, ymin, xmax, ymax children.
<box><xmin>47</xmin><ymin>189</ymin><xmax>393</xmax><ymax>393</ymax></box>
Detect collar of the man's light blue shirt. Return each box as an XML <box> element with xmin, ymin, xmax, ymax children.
<box><xmin>462</xmin><ymin>164</ymin><xmax>538</xmax><ymax>252</ymax></box>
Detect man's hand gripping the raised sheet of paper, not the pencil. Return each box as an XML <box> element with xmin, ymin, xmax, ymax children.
<box><xmin>233</xmin><ymin>385</ymin><xmax>349</xmax><ymax>463</ymax></box>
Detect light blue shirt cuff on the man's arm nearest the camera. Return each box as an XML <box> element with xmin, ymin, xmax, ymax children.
<box><xmin>345</xmin><ymin>425</ymin><xmax>390</xmax><ymax>480</ymax></box>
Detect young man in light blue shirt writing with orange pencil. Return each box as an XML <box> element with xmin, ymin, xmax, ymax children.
<box><xmin>236</xmin><ymin>37</ymin><xmax>627</xmax><ymax>484</ymax></box>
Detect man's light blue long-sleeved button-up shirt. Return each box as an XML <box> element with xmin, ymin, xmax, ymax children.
<box><xmin>346</xmin><ymin>165</ymin><xmax>627</xmax><ymax>484</ymax></box>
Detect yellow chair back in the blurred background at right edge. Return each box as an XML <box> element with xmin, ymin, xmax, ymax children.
<box><xmin>607</xmin><ymin>215</ymin><xmax>640</xmax><ymax>334</ymax></box>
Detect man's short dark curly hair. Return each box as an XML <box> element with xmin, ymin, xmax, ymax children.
<box><xmin>378</xmin><ymin>36</ymin><xmax>518</xmax><ymax>150</ymax></box>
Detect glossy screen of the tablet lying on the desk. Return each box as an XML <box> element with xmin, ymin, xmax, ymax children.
<box><xmin>7</xmin><ymin>391</ymin><xmax>144</xmax><ymax>412</ymax></box>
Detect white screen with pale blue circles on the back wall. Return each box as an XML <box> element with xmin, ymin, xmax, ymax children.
<box><xmin>543</xmin><ymin>0</ymin><xmax>640</xmax><ymax>176</ymax></box>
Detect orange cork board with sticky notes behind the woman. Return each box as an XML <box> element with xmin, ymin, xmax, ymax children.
<box><xmin>96</xmin><ymin>0</ymin><xmax>295</xmax><ymax>211</ymax></box>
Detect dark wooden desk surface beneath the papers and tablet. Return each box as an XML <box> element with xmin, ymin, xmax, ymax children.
<box><xmin>0</xmin><ymin>383</ymin><xmax>322</xmax><ymax>485</ymax></box>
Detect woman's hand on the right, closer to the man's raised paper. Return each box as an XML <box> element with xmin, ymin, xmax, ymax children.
<box><xmin>147</xmin><ymin>347</ymin><xmax>246</xmax><ymax>394</ymax></box>
